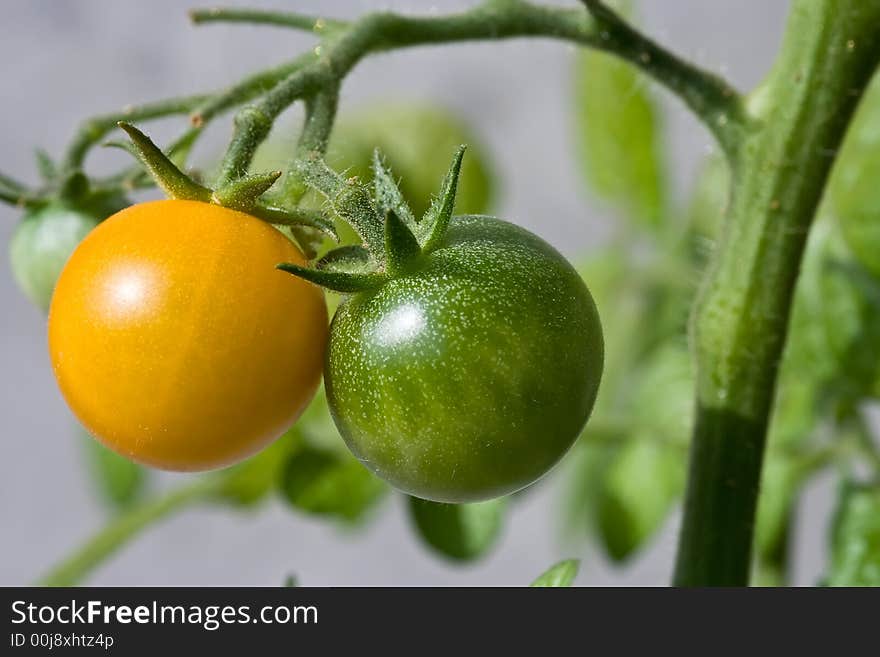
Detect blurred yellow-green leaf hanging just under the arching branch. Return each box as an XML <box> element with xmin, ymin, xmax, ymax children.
<box><xmin>574</xmin><ymin>4</ymin><xmax>666</xmax><ymax>230</ymax></box>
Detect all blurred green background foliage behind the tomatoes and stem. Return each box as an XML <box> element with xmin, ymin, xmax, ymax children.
<box><xmin>58</xmin><ymin>28</ymin><xmax>880</xmax><ymax>586</ymax></box>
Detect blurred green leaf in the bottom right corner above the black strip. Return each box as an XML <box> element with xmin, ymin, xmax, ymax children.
<box><xmin>826</xmin><ymin>482</ymin><xmax>880</xmax><ymax>586</ymax></box>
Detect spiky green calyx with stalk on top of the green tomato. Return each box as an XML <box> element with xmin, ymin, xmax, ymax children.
<box><xmin>278</xmin><ymin>146</ymin><xmax>465</xmax><ymax>293</ymax></box>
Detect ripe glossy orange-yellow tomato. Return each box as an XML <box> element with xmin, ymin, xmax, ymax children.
<box><xmin>49</xmin><ymin>200</ymin><xmax>327</xmax><ymax>471</ymax></box>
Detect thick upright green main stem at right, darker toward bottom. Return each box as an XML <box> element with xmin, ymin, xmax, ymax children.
<box><xmin>674</xmin><ymin>0</ymin><xmax>880</xmax><ymax>586</ymax></box>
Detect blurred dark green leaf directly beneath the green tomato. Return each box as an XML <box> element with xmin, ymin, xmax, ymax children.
<box><xmin>409</xmin><ymin>497</ymin><xmax>507</xmax><ymax>561</ymax></box>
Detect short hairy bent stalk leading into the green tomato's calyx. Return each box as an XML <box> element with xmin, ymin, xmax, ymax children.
<box><xmin>295</xmin><ymin>158</ymin><xmax>385</xmax><ymax>263</ymax></box>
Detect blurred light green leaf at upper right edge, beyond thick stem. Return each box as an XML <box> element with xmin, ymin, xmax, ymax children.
<box><xmin>829</xmin><ymin>76</ymin><xmax>880</xmax><ymax>276</ymax></box>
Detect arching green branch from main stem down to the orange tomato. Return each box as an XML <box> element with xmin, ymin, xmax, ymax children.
<box><xmin>213</xmin><ymin>0</ymin><xmax>745</xmax><ymax>185</ymax></box>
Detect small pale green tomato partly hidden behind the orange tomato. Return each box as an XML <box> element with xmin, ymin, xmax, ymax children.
<box><xmin>9</xmin><ymin>203</ymin><xmax>100</xmax><ymax>311</ymax></box>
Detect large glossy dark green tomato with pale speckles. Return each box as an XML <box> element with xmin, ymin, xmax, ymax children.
<box><xmin>324</xmin><ymin>216</ymin><xmax>603</xmax><ymax>502</ymax></box>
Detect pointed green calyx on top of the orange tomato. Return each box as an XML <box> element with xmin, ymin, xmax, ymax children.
<box><xmin>106</xmin><ymin>122</ymin><xmax>337</xmax><ymax>239</ymax></box>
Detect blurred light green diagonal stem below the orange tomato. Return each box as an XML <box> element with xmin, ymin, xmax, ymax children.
<box><xmin>37</xmin><ymin>476</ymin><xmax>222</xmax><ymax>586</ymax></box>
